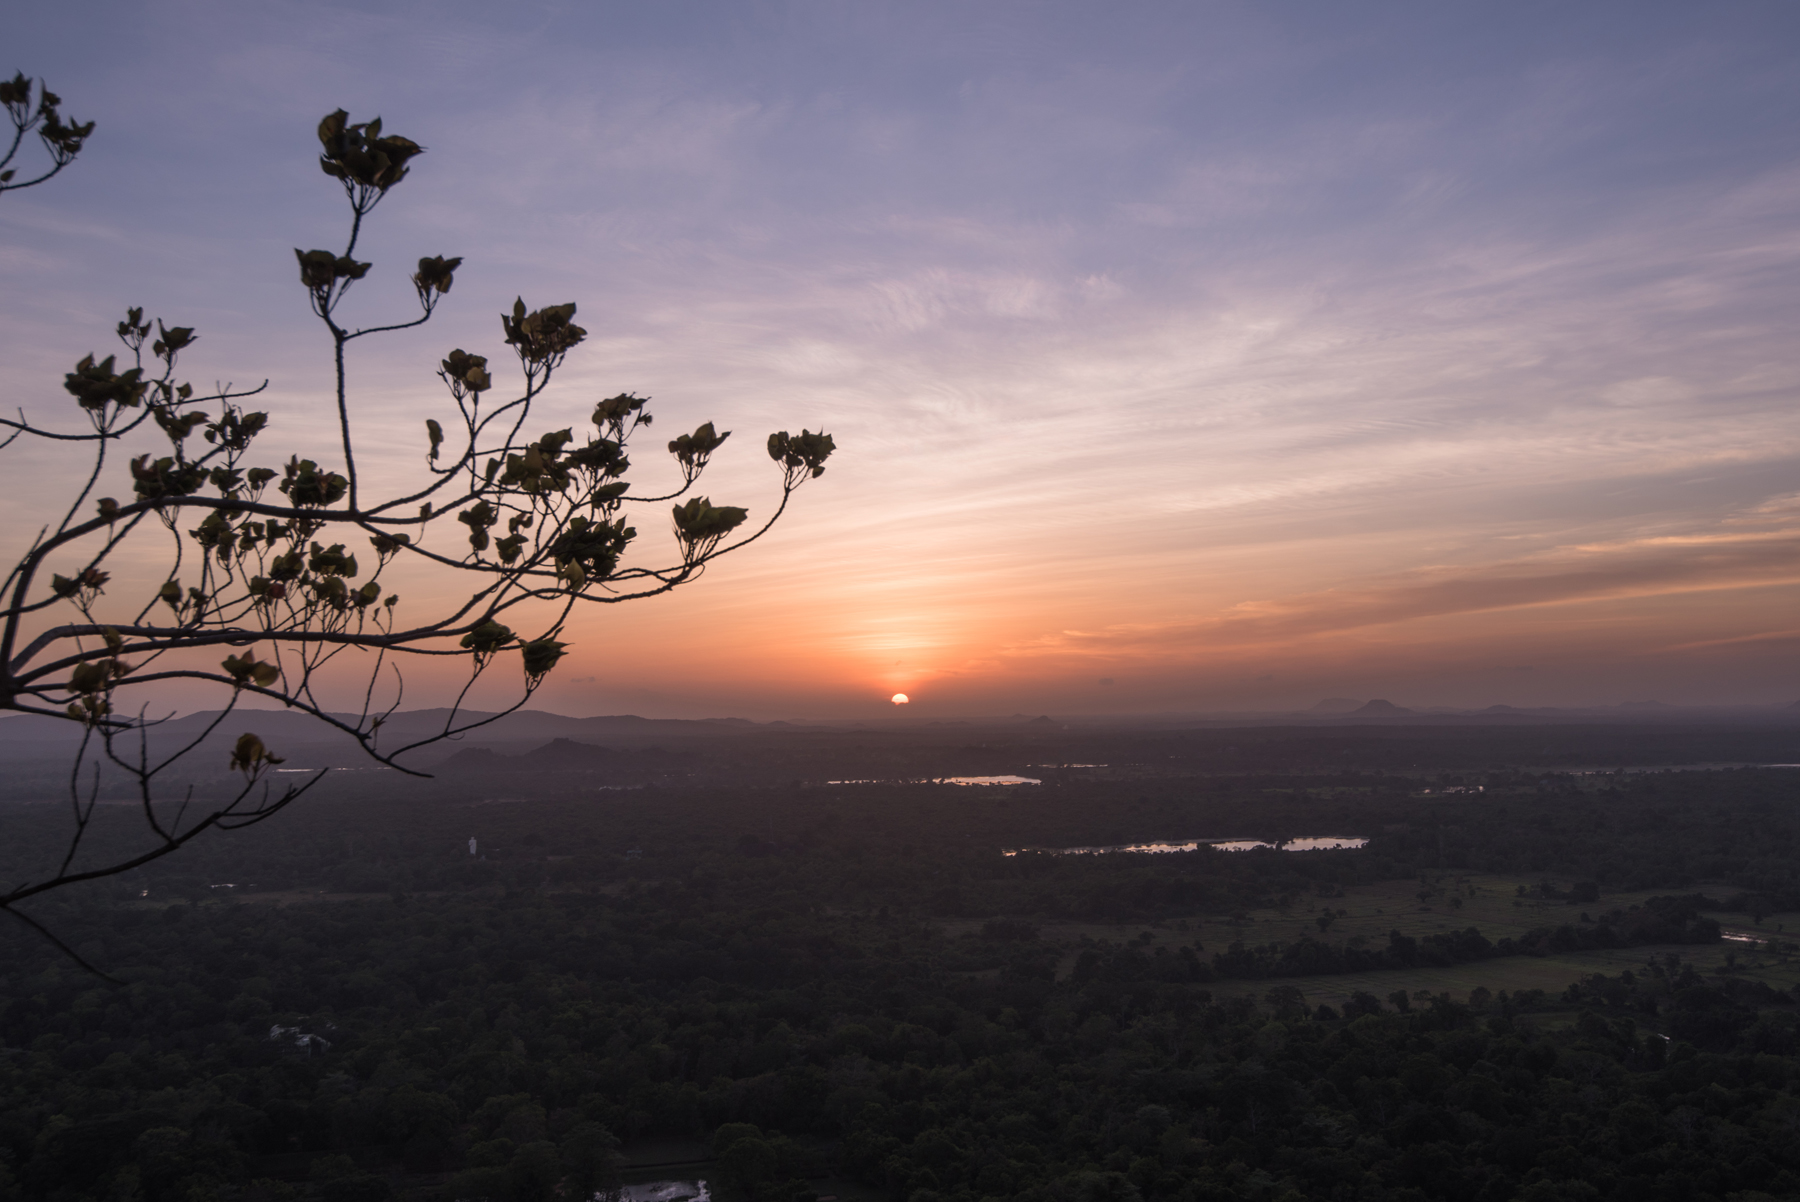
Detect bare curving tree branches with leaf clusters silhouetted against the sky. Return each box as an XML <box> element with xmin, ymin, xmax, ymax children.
<box><xmin>0</xmin><ymin>100</ymin><xmax>833</xmax><ymax>950</ymax></box>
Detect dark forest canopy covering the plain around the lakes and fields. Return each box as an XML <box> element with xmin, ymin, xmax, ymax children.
<box><xmin>0</xmin><ymin>759</ymin><xmax>1800</xmax><ymax>1202</ymax></box>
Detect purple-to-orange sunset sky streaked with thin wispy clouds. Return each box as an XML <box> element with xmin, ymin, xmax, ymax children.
<box><xmin>0</xmin><ymin>0</ymin><xmax>1800</xmax><ymax>720</ymax></box>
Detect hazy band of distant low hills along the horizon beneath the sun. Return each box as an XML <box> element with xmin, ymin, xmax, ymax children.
<box><xmin>0</xmin><ymin>711</ymin><xmax>1800</xmax><ymax>801</ymax></box>
